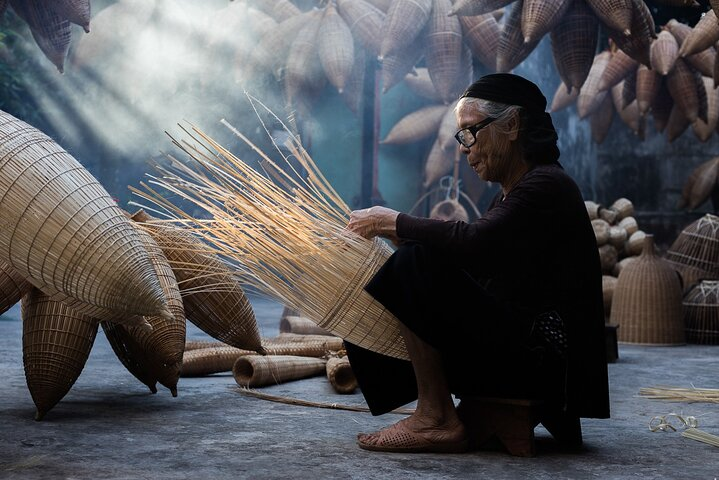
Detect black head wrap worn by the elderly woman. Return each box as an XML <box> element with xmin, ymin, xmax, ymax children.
<box><xmin>460</xmin><ymin>73</ymin><xmax>559</xmax><ymax>164</ymax></box>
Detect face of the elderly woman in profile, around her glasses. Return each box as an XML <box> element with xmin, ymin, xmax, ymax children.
<box><xmin>457</xmin><ymin>104</ymin><xmax>512</xmax><ymax>183</ymax></box>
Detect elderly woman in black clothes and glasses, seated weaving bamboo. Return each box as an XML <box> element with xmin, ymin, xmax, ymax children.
<box><xmin>347</xmin><ymin>74</ymin><xmax>609</xmax><ymax>452</ymax></box>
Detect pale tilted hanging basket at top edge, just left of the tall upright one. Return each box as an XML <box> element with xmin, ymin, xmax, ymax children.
<box><xmin>380</xmin><ymin>0</ymin><xmax>432</xmax><ymax>58</ymax></box>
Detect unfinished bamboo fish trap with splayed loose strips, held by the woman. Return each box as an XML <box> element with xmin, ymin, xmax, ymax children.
<box><xmin>134</xmin><ymin>100</ymin><xmax>408</xmax><ymax>359</ymax></box>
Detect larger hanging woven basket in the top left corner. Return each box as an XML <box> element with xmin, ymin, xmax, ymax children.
<box><xmin>10</xmin><ymin>0</ymin><xmax>72</xmax><ymax>73</ymax></box>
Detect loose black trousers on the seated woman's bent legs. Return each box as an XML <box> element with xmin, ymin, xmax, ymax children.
<box><xmin>345</xmin><ymin>243</ymin><xmax>564</xmax><ymax>415</ymax></box>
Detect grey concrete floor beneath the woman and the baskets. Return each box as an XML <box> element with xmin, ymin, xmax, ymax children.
<box><xmin>0</xmin><ymin>298</ymin><xmax>719</xmax><ymax>480</ymax></box>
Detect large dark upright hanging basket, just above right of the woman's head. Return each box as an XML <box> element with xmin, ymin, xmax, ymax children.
<box><xmin>550</xmin><ymin>0</ymin><xmax>599</xmax><ymax>92</ymax></box>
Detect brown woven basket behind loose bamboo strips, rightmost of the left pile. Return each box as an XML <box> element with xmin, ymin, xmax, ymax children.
<box><xmin>131</xmin><ymin>210</ymin><xmax>261</xmax><ymax>350</ymax></box>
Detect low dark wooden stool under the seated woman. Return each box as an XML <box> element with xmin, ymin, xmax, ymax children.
<box><xmin>457</xmin><ymin>397</ymin><xmax>582</xmax><ymax>457</ymax></box>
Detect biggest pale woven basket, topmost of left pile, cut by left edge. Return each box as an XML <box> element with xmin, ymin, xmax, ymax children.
<box><xmin>0</xmin><ymin>112</ymin><xmax>171</xmax><ymax>316</ymax></box>
